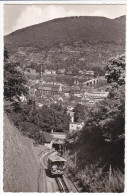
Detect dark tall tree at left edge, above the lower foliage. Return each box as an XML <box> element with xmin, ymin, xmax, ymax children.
<box><xmin>4</xmin><ymin>49</ymin><xmax>28</xmax><ymax>101</ymax></box>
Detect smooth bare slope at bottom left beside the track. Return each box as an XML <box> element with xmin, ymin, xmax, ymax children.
<box><xmin>3</xmin><ymin>115</ymin><xmax>39</xmax><ymax>192</ymax></box>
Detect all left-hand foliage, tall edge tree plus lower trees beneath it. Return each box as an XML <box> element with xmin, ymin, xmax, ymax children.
<box><xmin>4</xmin><ymin>49</ymin><xmax>69</xmax><ymax>144</ymax></box>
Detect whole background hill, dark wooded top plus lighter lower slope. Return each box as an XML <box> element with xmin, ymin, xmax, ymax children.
<box><xmin>5</xmin><ymin>16</ymin><xmax>125</xmax><ymax>75</ymax></box>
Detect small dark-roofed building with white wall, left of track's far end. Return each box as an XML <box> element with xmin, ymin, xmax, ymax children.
<box><xmin>43</xmin><ymin>131</ymin><xmax>53</xmax><ymax>149</ymax></box>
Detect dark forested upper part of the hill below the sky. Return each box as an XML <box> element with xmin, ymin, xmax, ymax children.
<box><xmin>5</xmin><ymin>16</ymin><xmax>125</xmax><ymax>51</ymax></box>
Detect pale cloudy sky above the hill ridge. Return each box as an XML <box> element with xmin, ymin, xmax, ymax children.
<box><xmin>4</xmin><ymin>4</ymin><xmax>126</xmax><ymax>35</ymax></box>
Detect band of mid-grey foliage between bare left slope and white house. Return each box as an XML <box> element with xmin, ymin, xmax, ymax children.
<box><xmin>5</xmin><ymin>101</ymin><xmax>69</xmax><ymax>144</ymax></box>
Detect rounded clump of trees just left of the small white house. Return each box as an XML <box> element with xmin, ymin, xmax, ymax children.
<box><xmin>22</xmin><ymin>105</ymin><xmax>69</xmax><ymax>132</ymax></box>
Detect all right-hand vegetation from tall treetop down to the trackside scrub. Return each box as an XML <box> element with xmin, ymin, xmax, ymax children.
<box><xmin>66</xmin><ymin>55</ymin><xmax>125</xmax><ymax>192</ymax></box>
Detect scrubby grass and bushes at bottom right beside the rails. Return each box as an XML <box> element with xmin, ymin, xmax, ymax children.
<box><xmin>68</xmin><ymin>165</ymin><xmax>124</xmax><ymax>192</ymax></box>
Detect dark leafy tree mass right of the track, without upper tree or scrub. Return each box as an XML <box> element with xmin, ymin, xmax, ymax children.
<box><xmin>78</xmin><ymin>86</ymin><xmax>125</xmax><ymax>170</ymax></box>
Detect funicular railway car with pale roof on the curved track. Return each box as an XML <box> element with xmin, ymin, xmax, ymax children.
<box><xmin>48</xmin><ymin>155</ymin><xmax>66</xmax><ymax>175</ymax></box>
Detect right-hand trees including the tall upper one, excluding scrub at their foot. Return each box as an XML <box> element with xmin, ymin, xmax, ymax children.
<box><xmin>68</xmin><ymin>55</ymin><xmax>125</xmax><ymax>172</ymax></box>
